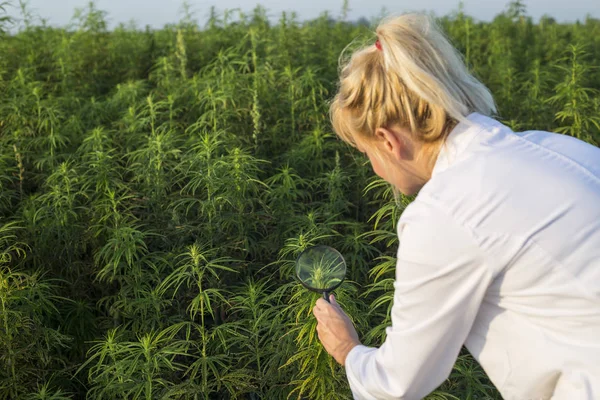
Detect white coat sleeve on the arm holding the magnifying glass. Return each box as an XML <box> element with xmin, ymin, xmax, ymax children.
<box><xmin>345</xmin><ymin>202</ymin><xmax>493</xmax><ymax>400</ymax></box>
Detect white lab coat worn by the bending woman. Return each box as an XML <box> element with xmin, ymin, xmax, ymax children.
<box><xmin>345</xmin><ymin>113</ymin><xmax>600</xmax><ymax>400</ymax></box>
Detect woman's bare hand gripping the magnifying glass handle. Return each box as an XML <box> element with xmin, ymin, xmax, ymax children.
<box><xmin>313</xmin><ymin>295</ymin><xmax>360</xmax><ymax>365</ymax></box>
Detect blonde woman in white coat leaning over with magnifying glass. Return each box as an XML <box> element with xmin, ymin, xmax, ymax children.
<box><xmin>313</xmin><ymin>14</ymin><xmax>600</xmax><ymax>400</ymax></box>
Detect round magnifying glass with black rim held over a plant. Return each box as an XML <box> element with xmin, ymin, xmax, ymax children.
<box><xmin>296</xmin><ymin>245</ymin><xmax>346</xmax><ymax>301</ymax></box>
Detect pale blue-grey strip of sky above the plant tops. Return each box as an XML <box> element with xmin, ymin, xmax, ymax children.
<box><xmin>0</xmin><ymin>0</ymin><xmax>600</xmax><ymax>28</ymax></box>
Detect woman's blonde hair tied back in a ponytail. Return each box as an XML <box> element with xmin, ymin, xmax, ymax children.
<box><xmin>330</xmin><ymin>14</ymin><xmax>496</xmax><ymax>146</ymax></box>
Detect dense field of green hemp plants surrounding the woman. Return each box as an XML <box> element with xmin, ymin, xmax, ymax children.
<box><xmin>0</xmin><ymin>1</ymin><xmax>600</xmax><ymax>400</ymax></box>
